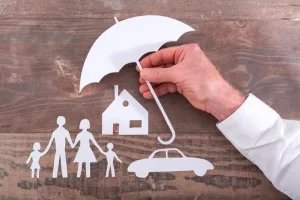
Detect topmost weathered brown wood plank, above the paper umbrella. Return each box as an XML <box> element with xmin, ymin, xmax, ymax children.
<box><xmin>0</xmin><ymin>0</ymin><xmax>300</xmax><ymax>21</ymax></box>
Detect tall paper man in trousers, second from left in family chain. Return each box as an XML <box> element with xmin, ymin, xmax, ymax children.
<box><xmin>43</xmin><ymin>116</ymin><xmax>73</xmax><ymax>178</ymax></box>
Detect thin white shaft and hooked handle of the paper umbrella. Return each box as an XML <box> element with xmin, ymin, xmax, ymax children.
<box><xmin>136</xmin><ymin>61</ymin><xmax>176</xmax><ymax>145</ymax></box>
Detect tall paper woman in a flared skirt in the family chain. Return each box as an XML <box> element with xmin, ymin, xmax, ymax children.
<box><xmin>72</xmin><ymin>119</ymin><xmax>104</xmax><ymax>178</ymax></box>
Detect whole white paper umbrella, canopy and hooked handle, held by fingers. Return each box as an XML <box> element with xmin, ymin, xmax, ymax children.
<box><xmin>80</xmin><ymin>15</ymin><xmax>194</xmax><ymax>144</ymax></box>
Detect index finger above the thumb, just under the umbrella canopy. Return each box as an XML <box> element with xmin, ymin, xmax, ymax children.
<box><xmin>140</xmin><ymin>46</ymin><xmax>182</xmax><ymax>68</ymax></box>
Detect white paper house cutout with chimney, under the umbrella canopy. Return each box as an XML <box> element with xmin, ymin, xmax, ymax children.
<box><xmin>102</xmin><ymin>85</ymin><xmax>148</xmax><ymax>135</ymax></box>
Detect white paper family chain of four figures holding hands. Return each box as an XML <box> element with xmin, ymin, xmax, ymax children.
<box><xmin>26</xmin><ymin>116</ymin><xmax>122</xmax><ymax>178</ymax></box>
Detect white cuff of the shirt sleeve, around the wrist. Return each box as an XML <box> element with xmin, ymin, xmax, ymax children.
<box><xmin>217</xmin><ymin>94</ymin><xmax>280</xmax><ymax>150</ymax></box>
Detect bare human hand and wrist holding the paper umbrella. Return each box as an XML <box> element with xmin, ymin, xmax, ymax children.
<box><xmin>140</xmin><ymin>44</ymin><xmax>245</xmax><ymax>120</ymax></box>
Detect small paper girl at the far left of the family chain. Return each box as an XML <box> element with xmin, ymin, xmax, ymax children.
<box><xmin>26</xmin><ymin>142</ymin><xmax>46</xmax><ymax>178</ymax></box>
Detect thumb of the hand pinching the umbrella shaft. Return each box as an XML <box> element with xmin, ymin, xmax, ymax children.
<box><xmin>141</xmin><ymin>67</ymin><xmax>176</xmax><ymax>83</ymax></box>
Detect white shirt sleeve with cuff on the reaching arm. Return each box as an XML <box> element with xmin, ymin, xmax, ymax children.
<box><xmin>217</xmin><ymin>94</ymin><xmax>300</xmax><ymax>199</ymax></box>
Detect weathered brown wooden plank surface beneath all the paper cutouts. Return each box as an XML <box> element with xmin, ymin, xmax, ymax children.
<box><xmin>0</xmin><ymin>0</ymin><xmax>300</xmax><ymax>200</ymax></box>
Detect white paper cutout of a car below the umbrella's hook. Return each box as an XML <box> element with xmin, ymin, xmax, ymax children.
<box><xmin>128</xmin><ymin>148</ymin><xmax>214</xmax><ymax>178</ymax></box>
